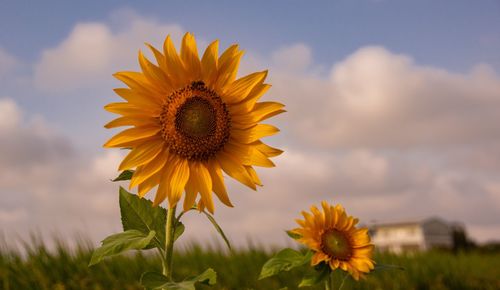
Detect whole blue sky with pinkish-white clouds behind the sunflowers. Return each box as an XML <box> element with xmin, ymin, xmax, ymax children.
<box><xmin>0</xmin><ymin>0</ymin><xmax>500</xmax><ymax>246</ymax></box>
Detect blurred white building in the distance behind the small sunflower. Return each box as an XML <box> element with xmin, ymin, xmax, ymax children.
<box><xmin>369</xmin><ymin>218</ymin><xmax>463</xmax><ymax>253</ymax></box>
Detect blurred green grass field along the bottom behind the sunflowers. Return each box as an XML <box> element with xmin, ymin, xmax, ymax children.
<box><xmin>0</xmin><ymin>239</ymin><xmax>500</xmax><ymax>290</ymax></box>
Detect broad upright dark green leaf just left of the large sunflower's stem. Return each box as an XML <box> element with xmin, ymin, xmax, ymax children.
<box><xmin>120</xmin><ymin>187</ymin><xmax>167</xmax><ymax>249</ymax></box>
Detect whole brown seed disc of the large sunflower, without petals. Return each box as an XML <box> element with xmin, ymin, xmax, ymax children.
<box><xmin>159</xmin><ymin>81</ymin><xmax>231</xmax><ymax>161</ymax></box>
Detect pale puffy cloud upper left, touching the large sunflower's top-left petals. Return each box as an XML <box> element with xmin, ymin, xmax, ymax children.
<box><xmin>34</xmin><ymin>13</ymin><xmax>183</xmax><ymax>93</ymax></box>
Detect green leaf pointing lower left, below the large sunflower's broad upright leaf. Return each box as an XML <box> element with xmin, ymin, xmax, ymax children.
<box><xmin>89</xmin><ymin>230</ymin><xmax>155</xmax><ymax>266</ymax></box>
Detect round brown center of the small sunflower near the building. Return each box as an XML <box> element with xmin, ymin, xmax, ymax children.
<box><xmin>321</xmin><ymin>229</ymin><xmax>352</xmax><ymax>261</ymax></box>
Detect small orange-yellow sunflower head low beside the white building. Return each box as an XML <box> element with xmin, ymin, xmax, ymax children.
<box><xmin>292</xmin><ymin>201</ymin><xmax>375</xmax><ymax>280</ymax></box>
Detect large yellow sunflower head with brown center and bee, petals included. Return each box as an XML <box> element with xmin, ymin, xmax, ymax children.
<box><xmin>104</xmin><ymin>33</ymin><xmax>284</xmax><ymax>213</ymax></box>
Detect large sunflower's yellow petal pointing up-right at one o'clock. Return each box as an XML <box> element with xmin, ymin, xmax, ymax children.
<box><xmin>215</xmin><ymin>44</ymin><xmax>243</xmax><ymax>92</ymax></box>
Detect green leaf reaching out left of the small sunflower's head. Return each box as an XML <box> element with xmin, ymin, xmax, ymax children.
<box><xmin>259</xmin><ymin>248</ymin><xmax>312</xmax><ymax>280</ymax></box>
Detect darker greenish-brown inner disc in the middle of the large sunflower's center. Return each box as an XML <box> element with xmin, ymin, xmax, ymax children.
<box><xmin>175</xmin><ymin>96</ymin><xmax>216</xmax><ymax>138</ymax></box>
